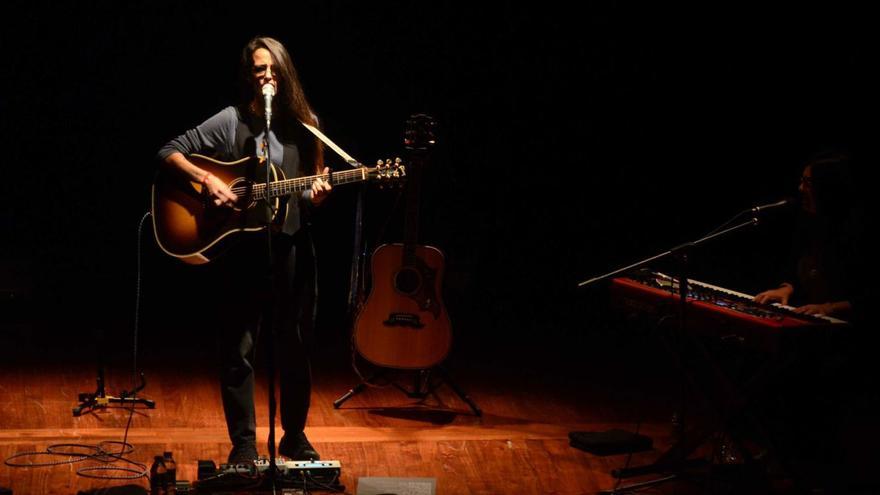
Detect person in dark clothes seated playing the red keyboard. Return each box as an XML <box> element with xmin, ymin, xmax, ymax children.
<box><xmin>754</xmin><ymin>155</ymin><xmax>876</xmax><ymax>493</ymax></box>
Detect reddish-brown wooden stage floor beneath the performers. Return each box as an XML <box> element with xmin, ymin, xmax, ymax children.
<box><xmin>0</xmin><ymin>320</ymin><xmax>876</xmax><ymax>494</ymax></box>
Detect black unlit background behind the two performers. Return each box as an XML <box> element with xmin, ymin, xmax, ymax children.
<box><xmin>0</xmin><ymin>1</ymin><xmax>880</xmax><ymax>354</ymax></box>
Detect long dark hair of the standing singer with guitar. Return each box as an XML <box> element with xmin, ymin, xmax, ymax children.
<box><xmin>240</xmin><ymin>36</ymin><xmax>324</xmax><ymax>173</ymax></box>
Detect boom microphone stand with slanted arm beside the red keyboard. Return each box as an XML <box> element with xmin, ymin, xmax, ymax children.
<box><xmin>577</xmin><ymin>215</ymin><xmax>760</xmax><ymax>495</ymax></box>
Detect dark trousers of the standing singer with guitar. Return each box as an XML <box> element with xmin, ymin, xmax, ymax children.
<box><xmin>211</xmin><ymin>234</ymin><xmax>317</xmax><ymax>445</ymax></box>
